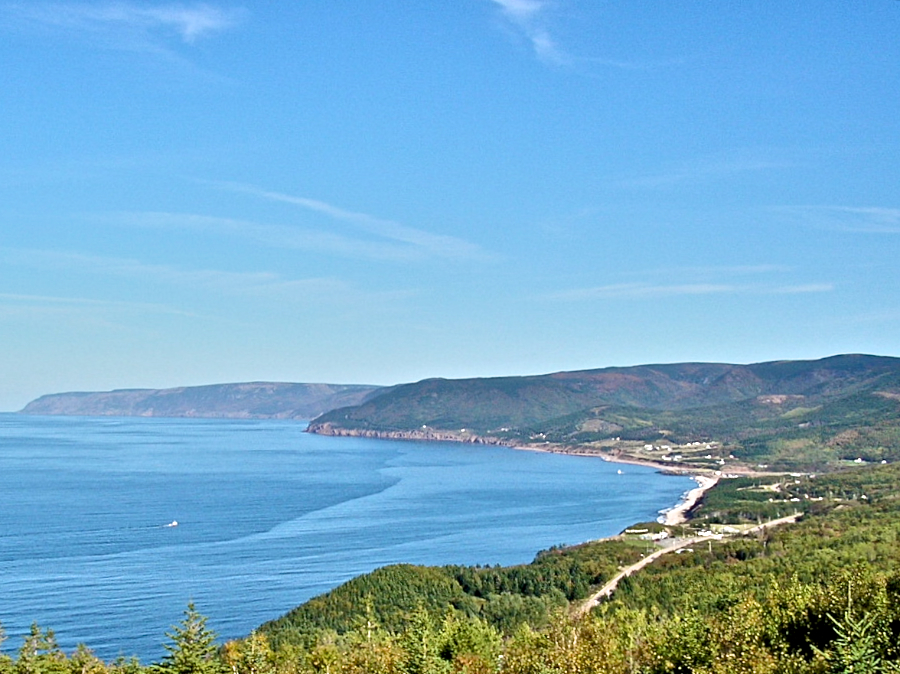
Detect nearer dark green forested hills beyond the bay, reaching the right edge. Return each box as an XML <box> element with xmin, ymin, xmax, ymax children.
<box><xmin>310</xmin><ymin>355</ymin><xmax>900</xmax><ymax>468</ymax></box>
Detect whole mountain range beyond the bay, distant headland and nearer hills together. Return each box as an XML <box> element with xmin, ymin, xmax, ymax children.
<box><xmin>22</xmin><ymin>354</ymin><xmax>900</xmax><ymax>470</ymax></box>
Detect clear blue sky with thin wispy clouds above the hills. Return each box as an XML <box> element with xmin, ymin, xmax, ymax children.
<box><xmin>0</xmin><ymin>0</ymin><xmax>900</xmax><ymax>410</ymax></box>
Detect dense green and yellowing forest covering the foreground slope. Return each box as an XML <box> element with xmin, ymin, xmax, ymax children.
<box><xmin>7</xmin><ymin>464</ymin><xmax>900</xmax><ymax>674</ymax></box>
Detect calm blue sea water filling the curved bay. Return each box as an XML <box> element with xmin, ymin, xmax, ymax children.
<box><xmin>0</xmin><ymin>414</ymin><xmax>692</xmax><ymax>663</ymax></box>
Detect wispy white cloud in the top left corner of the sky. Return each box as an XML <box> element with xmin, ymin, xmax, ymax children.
<box><xmin>0</xmin><ymin>2</ymin><xmax>243</xmax><ymax>55</ymax></box>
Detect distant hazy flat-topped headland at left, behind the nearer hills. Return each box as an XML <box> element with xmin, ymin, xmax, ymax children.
<box><xmin>22</xmin><ymin>382</ymin><xmax>379</xmax><ymax>419</ymax></box>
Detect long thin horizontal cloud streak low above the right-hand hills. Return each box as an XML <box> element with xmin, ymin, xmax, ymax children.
<box><xmin>541</xmin><ymin>283</ymin><xmax>834</xmax><ymax>302</ymax></box>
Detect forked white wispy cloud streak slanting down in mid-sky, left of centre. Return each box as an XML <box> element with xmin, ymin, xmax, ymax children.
<box><xmin>201</xmin><ymin>182</ymin><xmax>491</xmax><ymax>261</ymax></box>
